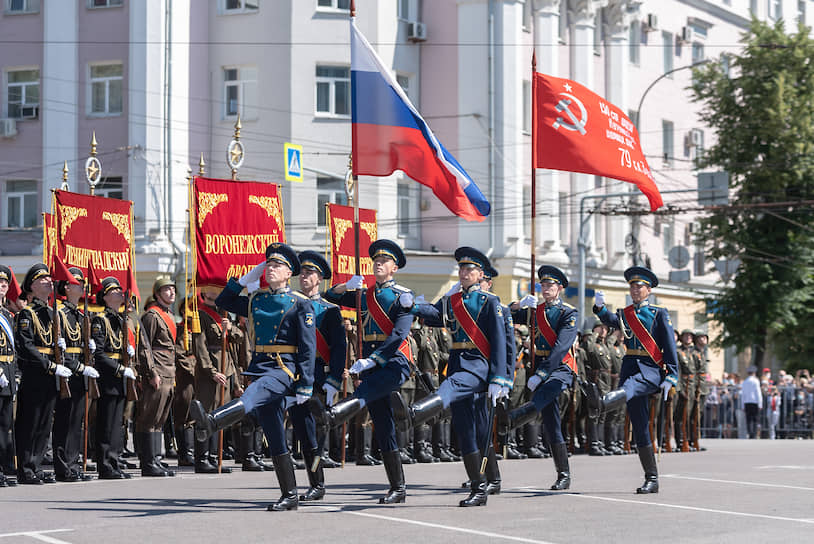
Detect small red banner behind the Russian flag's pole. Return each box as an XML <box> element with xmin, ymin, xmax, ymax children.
<box><xmin>328</xmin><ymin>204</ymin><xmax>378</xmax><ymax>285</ymax></box>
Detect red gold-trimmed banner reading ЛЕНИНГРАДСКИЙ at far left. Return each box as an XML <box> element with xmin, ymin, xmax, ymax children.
<box><xmin>52</xmin><ymin>191</ymin><xmax>134</xmax><ymax>294</ymax></box>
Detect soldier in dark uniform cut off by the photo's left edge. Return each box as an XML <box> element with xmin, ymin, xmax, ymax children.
<box><xmin>0</xmin><ymin>265</ymin><xmax>17</xmax><ymax>487</ymax></box>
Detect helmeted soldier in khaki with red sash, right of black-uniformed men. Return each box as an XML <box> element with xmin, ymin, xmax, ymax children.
<box><xmin>135</xmin><ymin>277</ymin><xmax>178</xmax><ymax>476</ymax></box>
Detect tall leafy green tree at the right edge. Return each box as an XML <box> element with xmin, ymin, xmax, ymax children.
<box><xmin>691</xmin><ymin>19</ymin><xmax>814</xmax><ymax>367</ymax></box>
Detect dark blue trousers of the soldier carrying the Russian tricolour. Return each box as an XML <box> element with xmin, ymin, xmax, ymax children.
<box><xmin>353</xmin><ymin>363</ymin><xmax>407</xmax><ymax>452</ymax></box>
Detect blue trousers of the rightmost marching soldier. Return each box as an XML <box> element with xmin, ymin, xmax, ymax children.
<box><xmin>619</xmin><ymin>357</ymin><xmax>661</xmax><ymax>448</ymax></box>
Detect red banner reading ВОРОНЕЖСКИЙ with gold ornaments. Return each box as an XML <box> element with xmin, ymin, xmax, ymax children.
<box><xmin>192</xmin><ymin>177</ymin><xmax>285</xmax><ymax>287</ymax></box>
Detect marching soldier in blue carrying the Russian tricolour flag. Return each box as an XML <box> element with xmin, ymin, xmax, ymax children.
<box><xmin>325</xmin><ymin>240</ymin><xmax>413</xmax><ymax>504</ymax></box>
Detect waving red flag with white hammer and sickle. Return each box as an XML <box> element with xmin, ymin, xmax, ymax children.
<box><xmin>532</xmin><ymin>73</ymin><xmax>663</xmax><ymax>211</ymax></box>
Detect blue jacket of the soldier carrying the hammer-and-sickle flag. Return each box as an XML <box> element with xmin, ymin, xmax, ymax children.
<box><xmin>512</xmin><ymin>298</ymin><xmax>577</xmax><ymax>382</ymax></box>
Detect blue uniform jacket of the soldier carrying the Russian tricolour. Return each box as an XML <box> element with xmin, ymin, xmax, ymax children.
<box><xmin>324</xmin><ymin>280</ymin><xmax>413</xmax><ymax>375</ymax></box>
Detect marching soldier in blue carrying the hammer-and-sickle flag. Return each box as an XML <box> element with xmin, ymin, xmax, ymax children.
<box><xmin>498</xmin><ymin>265</ymin><xmax>578</xmax><ymax>491</ymax></box>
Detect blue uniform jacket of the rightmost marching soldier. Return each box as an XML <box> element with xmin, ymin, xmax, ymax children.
<box><xmin>594</xmin><ymin>300</ymin><xmax>678</xmax><ymax>385</ymax></box>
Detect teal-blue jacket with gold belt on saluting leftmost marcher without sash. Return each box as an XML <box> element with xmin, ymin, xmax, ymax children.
<box><xmin>215</xmin><ymin>278</ymin><xmax>317</xmax><ymax>396</ymax></box>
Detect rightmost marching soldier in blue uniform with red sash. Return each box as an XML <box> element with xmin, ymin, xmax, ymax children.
<box><xmin>588</xmin><ymin>266</ymin><xmax>678</xmax><ymax>493</ymax></box>
